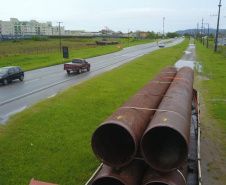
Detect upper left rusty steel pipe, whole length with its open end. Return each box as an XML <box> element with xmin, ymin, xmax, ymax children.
<box><xmin>91</xmin><ymin>66</ymin><xmax>177</xmax><ymax>167</ymax></box>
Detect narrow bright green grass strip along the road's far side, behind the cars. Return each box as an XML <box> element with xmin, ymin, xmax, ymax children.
<box><xmin>0</xmin><ymin>40</ymin><xmax>154</xmax><ymax>71</ymax></box>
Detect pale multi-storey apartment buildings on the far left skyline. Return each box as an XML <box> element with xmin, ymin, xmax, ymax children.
<box><xmin>0</xmin><ymin>18</ymin><xmax>65</xmax><ymax>35</ymax></box>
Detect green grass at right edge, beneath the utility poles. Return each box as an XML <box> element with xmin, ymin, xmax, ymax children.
<box><xmin>196</xmin><ymin>41</ymin><xmax>226</xmax><ymax>152</ymax></box>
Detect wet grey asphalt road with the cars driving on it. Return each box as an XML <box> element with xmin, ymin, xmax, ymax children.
<box><xmin>0</xmin><ymin>39</ymin><xmax>183</xmax><ymax>124</ymax></box>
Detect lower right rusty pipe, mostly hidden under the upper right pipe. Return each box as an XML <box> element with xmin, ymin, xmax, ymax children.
<box><xmin>141</xmin><ymin>165</ymin><xmax>188</xmax><ymax>185</ymax></box>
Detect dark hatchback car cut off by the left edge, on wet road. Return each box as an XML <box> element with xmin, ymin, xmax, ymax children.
<box><xmin>0</xmin><ymin>66</ymin><xmax>24</xmax><ymax>85</ymax></box>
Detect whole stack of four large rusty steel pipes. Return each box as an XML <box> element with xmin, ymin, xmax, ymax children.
<box><xmin>92</xmin><ymin>67</ymin><xmax>193</xmax><ymax>185</ymax></box>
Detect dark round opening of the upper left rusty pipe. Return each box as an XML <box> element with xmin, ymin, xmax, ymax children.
<box><xmin>92</xmin><ymin>124</ymin><xmax>135</xmax><ymax>167</ymax></box>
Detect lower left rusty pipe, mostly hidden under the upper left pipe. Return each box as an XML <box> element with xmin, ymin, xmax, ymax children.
<box><xmin>92</xmin><ymin>160</ymin><xmax>146</xmax><ymax>185</ymax></box>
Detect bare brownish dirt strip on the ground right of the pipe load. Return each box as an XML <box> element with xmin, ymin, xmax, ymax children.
<box><xmin>195</xmin><ymin>76</ymin><xmax>226</xmax><ymax>185</ymax></box>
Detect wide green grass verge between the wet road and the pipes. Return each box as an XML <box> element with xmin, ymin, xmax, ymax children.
<box><xmin>0</xmin><ymin>40</ymin><xmax>189</xmax><ymax>185</ymax></box>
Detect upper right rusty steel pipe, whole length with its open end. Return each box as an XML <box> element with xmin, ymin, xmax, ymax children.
<box><xmin>140</xmin><ymin>67</ymin><xmax>194</xmax><ymax>172</ymax></box>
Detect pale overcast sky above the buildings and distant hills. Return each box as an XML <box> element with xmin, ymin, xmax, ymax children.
<box><xmin>0</xmin><ymin>0</ymin><xmax>226</xmax><ymax>32</ymax></box>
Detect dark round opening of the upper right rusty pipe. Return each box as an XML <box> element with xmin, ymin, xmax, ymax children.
<box><xmin>141</xmin><ymin>127</ymin><xmax>188</xmax><ymax>172</ymax></box>
